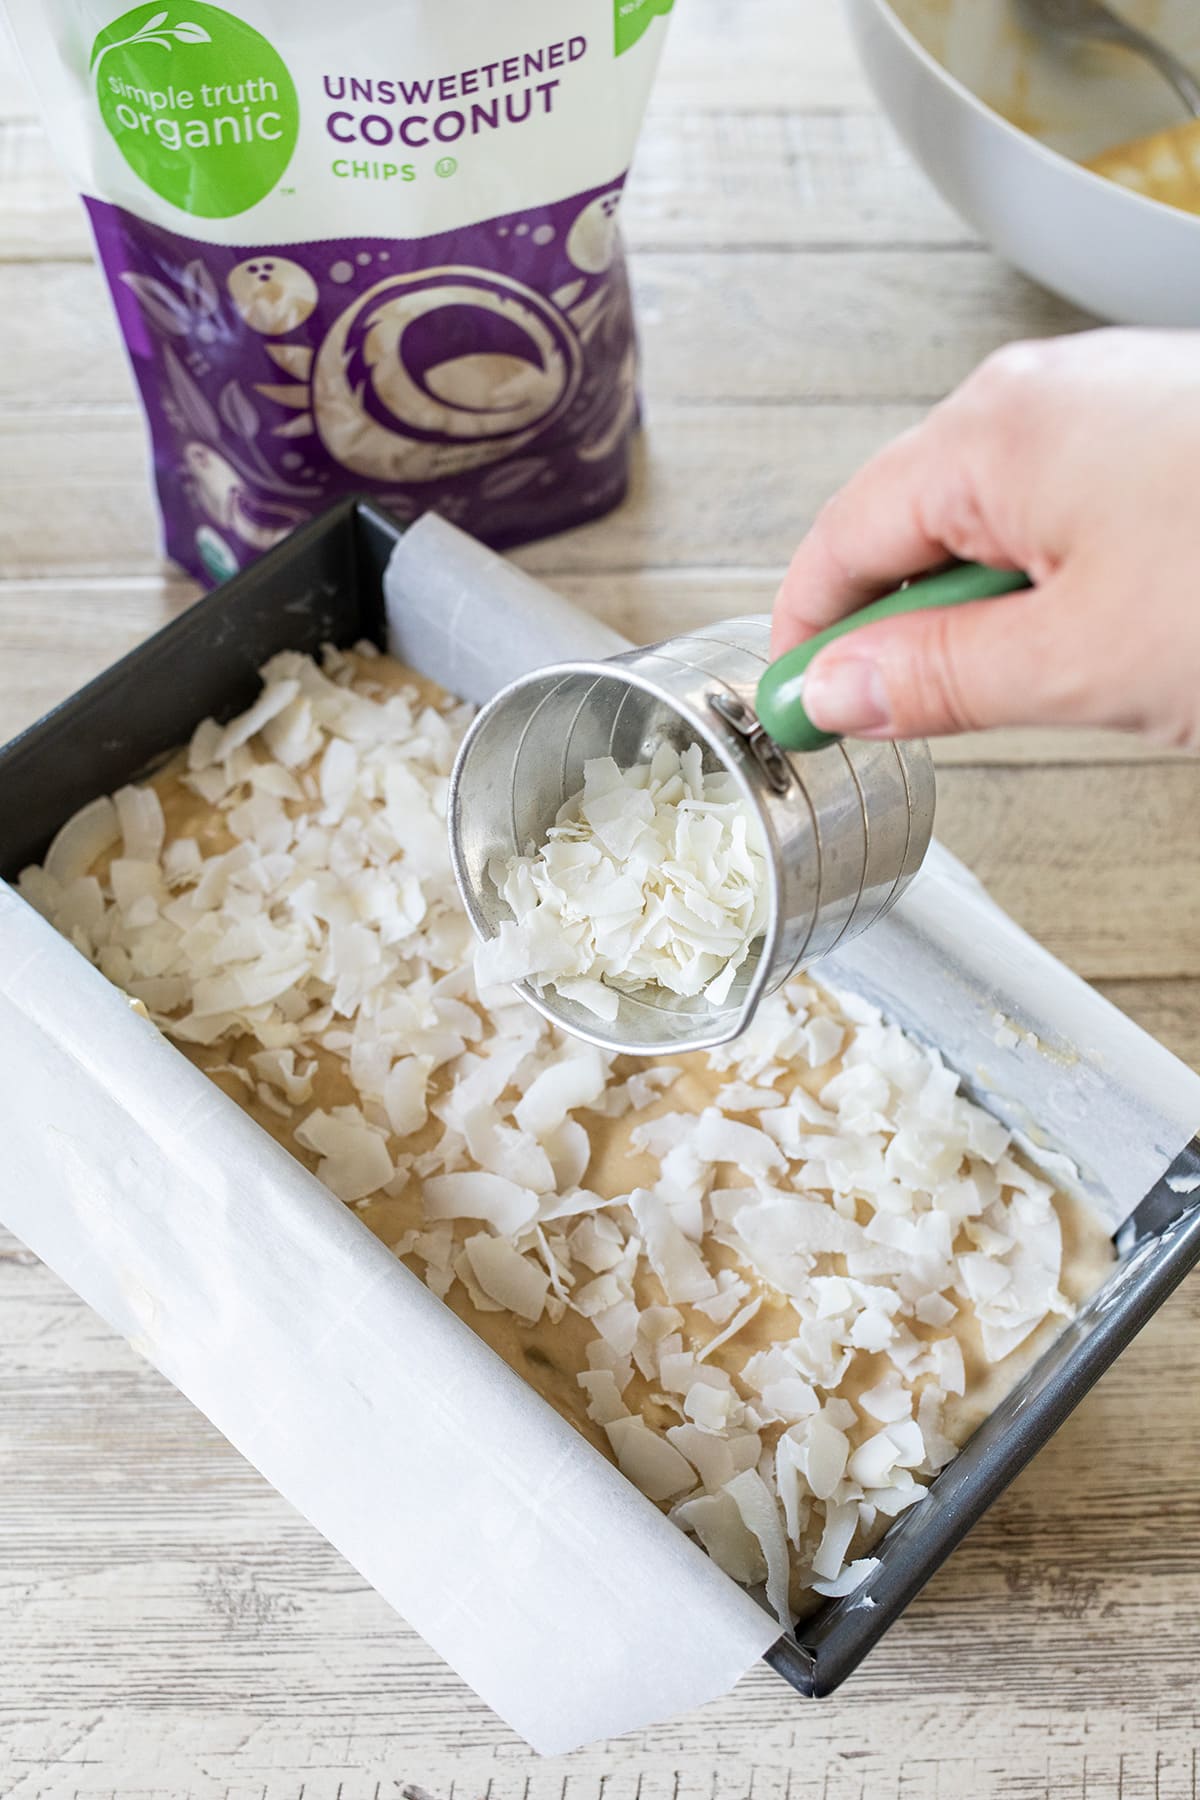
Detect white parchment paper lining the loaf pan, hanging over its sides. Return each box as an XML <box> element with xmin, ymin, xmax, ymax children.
<box><xmin>0</xmin><ymin>520</ymin><xmax>1200</xmax><ymax>1751</ymax></box>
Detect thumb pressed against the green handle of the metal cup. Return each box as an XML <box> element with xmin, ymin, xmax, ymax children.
<box><xmin>804</xmin><ymin>578</ymin><xmax>1099</xmax><ymax>738</ymax></box>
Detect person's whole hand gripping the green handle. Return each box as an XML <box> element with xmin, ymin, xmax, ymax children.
<box><xmin>772</xmin><ymin>331</ymin><xmax>1200</xmax><ymax>749</ymax></box>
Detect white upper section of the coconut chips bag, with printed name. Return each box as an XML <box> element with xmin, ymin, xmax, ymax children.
<box><xmin>5</xmin><ymin>0</ymin><xmax>671</xmax><ymax>241</ymax></box>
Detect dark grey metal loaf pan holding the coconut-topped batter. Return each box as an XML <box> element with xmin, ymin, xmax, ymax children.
<box><xmin>0</xmin><ymin>499</ymin><xmax>1200</xmax><ymax>1696</ymax></box>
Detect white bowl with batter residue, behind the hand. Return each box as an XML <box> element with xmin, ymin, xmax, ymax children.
<box><xmin>846</xmin><ymin>0</ymin><xmax>1200</xmax><ymax>326</ymax></box>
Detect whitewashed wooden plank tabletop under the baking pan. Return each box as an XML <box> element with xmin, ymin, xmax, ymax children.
<box><xmin>0</xmin><ymin>0</ymin><xmax>1200</xmax><ymax>1800</ymax></box>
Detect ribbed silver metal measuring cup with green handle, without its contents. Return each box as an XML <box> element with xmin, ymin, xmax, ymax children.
<box><xmin>450</xmin><ymin>563</ymin><xmax>1025</xmax><ymax>1055</ymax></box>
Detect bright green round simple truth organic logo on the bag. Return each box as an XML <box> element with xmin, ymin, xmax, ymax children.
<box><xmin>92</xmin><ymin>0</ymin><xmax>300</xmax><ymax>220</ymax></box>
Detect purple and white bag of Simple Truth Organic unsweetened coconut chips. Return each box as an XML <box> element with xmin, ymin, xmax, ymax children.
<box><xmin>7</xmin><ymin>0</ymin><xmax>673</xmax><ymax>581</ymax></box>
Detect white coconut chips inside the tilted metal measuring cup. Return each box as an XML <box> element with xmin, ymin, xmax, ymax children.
<box><xmin>475</xmin><ymin>743</ymin><xmax>766</xmax><ymax>1021</ymax></box>
